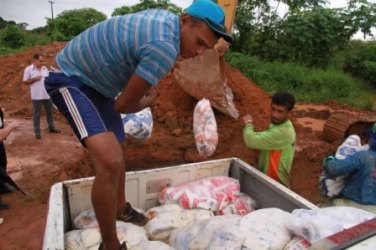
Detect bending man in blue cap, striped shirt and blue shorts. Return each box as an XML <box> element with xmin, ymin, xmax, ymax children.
<box><xmin>45</xmin><ymin>0</ymin><xmax>232</xmax><ymax>249</ymax></box>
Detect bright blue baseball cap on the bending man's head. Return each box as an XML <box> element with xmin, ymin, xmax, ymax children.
<box><xmin>185</xmin><ymin>0</ymin><xmax>232</xmax><ymax>43</ymax></box>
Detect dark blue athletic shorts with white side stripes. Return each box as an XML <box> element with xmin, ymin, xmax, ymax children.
<box><xmin>45</xmin><ymin>72</ymin><xmax>125</xmax><ymax>143</ymax></box>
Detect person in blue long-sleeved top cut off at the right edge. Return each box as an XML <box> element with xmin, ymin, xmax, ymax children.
<box><xmin>324</xmin><ymin>123</ymin><xmax>376</xmax><ymax>213</ymax></box>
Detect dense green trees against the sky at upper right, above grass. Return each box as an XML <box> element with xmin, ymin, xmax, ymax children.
<box><xmin>231</xmin><ymin>0</ymin><xmax>376</xmax><ymax>67</ymax></box>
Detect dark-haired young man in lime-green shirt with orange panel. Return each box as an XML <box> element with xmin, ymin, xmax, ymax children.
<box><xmin>243</xmin><ymin>92</ymin><xmax>296</xmax><ymax>186</ymax></box>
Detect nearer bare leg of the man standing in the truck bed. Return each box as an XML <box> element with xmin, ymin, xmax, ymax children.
<box><xmin>84</xmin><ymin>132</ymin><xmax>124</xmax><ymax>250</ymax></box>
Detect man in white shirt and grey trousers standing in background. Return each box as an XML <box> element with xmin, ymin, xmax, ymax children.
<box><xmin>23</xmin><ymin>53</ymin><xmax>60</xmax><ymax>139</ymax></box>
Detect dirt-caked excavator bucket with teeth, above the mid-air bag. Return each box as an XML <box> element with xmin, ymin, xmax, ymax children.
<box><xmin>174</xmin><ymin>49</ymin><xmax>239</xmax><ymax>118</ymax></box>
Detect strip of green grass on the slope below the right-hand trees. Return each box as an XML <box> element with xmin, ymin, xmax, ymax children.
<box><xmin>226</xmin><ymin>52</ymin><xmax>376</xmax><ymax>111</ymax></box>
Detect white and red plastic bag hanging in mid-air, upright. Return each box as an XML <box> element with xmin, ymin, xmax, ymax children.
<box><xmin>193</xmin><ymin>99</ymin><xmax>218</xmax><ymax>157</ymax></box>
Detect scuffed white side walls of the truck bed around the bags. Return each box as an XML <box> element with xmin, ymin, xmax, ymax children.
<box><xmin>43</xmin><ymin>158</ymin><xmax>350</xmax><ymax>249</ymax></box>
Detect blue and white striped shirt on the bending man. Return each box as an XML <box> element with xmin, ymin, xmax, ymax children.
<box><xmin>56</xmin><ymin>9</ymin><xmax>180</xmax><ymax>97</ymax></box>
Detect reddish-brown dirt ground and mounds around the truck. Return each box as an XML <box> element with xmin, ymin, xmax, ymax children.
<box><xmin>0</xmin><ymin>43</ymin><xmax>374</xmax><ymax>249</ymax></box>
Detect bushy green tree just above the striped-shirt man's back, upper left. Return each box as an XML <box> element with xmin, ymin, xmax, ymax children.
<box><xmin>47</xmin><ymin>8</ymin><xmax>107</xmax><ymax>40</ymax></box>
